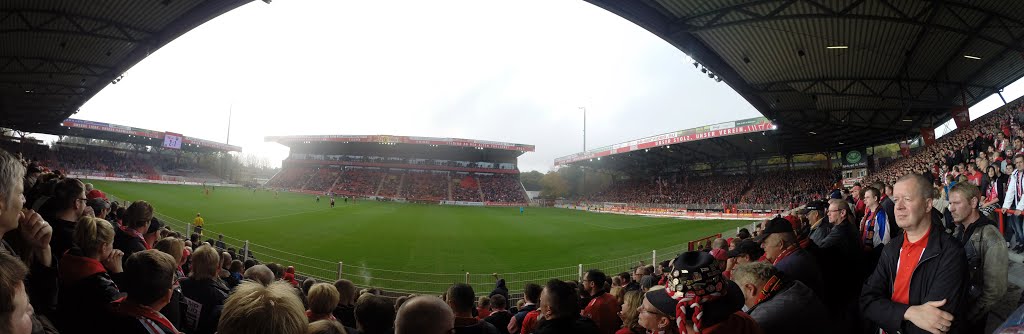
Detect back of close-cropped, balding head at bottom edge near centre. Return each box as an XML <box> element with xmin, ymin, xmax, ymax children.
<box><xmin>394</xmin><ymin>296</ymin><xmax>455</xmax><ymax>334</ymax></box>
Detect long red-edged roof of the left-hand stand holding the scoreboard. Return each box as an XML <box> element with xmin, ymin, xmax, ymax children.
<box><xmin>53</xmin><ymin>118</ymin><xmax>242</xmax><ymax>152</ymax></box>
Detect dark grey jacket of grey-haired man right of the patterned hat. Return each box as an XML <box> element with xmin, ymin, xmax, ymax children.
<box><xmin>748</xmin><ymin>281</ymin><xmax>830</xmax><ymax>334</ymax></box>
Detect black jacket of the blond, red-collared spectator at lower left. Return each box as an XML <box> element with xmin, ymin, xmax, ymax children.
<box><xmin>56</xmin><ymin>247</ymin><xmax>121</xmax><ymax>333</ymax></box>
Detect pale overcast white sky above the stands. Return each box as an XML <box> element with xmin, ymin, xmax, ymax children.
<box><xmin>61</xmin><ymin>0</ymin><xmax>1022</xmax><ymax>172</ymax></box>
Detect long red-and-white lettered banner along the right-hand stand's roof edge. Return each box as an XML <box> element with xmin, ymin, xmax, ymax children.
<box><xmin>555</xmin><ymin>117</ymin><xmax>775</xmax><ymax>166</ymax></box>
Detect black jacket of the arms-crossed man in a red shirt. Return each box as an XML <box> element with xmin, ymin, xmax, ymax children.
<box><xmin>860</xmin><ymin>221</ymin><xmax>968</xmax><ymax>333</ymax></box>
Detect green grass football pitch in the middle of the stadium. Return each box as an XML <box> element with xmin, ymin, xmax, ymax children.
<box><xmin>90</xmin><ymin>180</ymin><xmax>751</xmax><ymax>293</ymax></box>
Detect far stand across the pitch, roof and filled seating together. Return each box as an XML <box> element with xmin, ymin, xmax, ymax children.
<box><xmin>266</xmin><ymin>135</ymin><xmax>534</xmax><ymax>206</ymax></box>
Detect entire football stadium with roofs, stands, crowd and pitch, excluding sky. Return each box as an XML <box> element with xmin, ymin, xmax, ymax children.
<box><xmin>0</xmin><ymin>0</ymin><xmax>1024</xmax><ymax>334</ymax></box>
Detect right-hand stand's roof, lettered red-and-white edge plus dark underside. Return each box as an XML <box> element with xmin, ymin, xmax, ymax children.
<box><xmin>555</xmin><ymin>117</ymin><xmax>778</xmax><ymax>166</ymax></box>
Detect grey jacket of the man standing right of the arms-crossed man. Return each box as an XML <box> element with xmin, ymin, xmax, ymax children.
<box><xmin>954</xmin><ymin>216</ymin><xmax>1010</xmax><ymax>320</ymax></box>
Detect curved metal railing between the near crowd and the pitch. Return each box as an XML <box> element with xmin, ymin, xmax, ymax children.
<box><xmin>110</xmin><ymin>192</ymin><xmax>754</xmax><ymax>302</ymax></box>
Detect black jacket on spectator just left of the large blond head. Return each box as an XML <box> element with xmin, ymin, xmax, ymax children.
<box><xmin>181</xmin><ymin>278</ymin><xmax>230</xmax><ymax>334</ymax></box>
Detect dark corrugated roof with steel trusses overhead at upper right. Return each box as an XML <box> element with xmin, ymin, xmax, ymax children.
<box><xmin>587</xmin><ymin>0</ymin><xmax>1024</xmax><ymax>153</ymax></box>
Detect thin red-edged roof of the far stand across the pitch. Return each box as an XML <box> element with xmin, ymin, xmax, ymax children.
<box><xmin>264</xmin><ymin>134</ymin><xmax>535</xmax><ymax>157</ymax></box>
